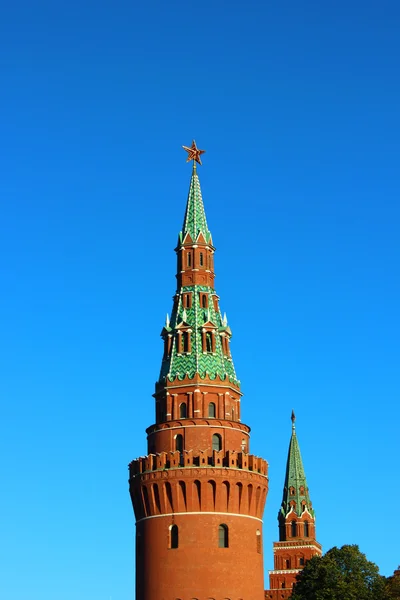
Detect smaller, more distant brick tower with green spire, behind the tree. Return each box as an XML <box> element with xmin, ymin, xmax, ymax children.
<box><xmin>265</xmin><ymin>411</ymin><xmax>322</xmax><ymax>600</ymax></box>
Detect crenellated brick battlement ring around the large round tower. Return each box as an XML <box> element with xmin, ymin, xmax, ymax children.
<box><xmin>129</xmin><ymin>450</ymin><xmax>268</xmax><ymax>477</ymax></box>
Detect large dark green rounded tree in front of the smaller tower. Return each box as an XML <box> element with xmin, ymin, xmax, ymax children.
<box><xmin>291</xmin><ymin>546</ymin><xmax>388</xmax><ymax>600</ymax></box>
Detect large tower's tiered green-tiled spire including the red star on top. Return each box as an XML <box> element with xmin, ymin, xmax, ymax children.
<box><xmin>159</xmin><ymin>146</ymin><xmax>240</xmax><ymax>388</ymax></box>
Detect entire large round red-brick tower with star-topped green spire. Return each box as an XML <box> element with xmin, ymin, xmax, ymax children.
<box><xmin>129</xmin><ymin>142</ymin><xmax>268</xmax><ymax>600</ymax></box>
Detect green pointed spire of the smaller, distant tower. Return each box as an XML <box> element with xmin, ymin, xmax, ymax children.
<box><xmin>279</xmin><ymin>411</ymin><xmax>314</xmax><ymax>517</ymax></box>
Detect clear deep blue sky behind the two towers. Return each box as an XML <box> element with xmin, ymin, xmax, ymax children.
<box><xmin>0</xmin><ymin>0</ymin><xmax>400</xmax><ymax>600</ymax></box>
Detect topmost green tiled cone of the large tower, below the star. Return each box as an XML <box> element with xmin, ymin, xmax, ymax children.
<box><xmin>179</xmin><ymin>162</ymin><xmax>211</xmax><ymax>243</ymax></box>
